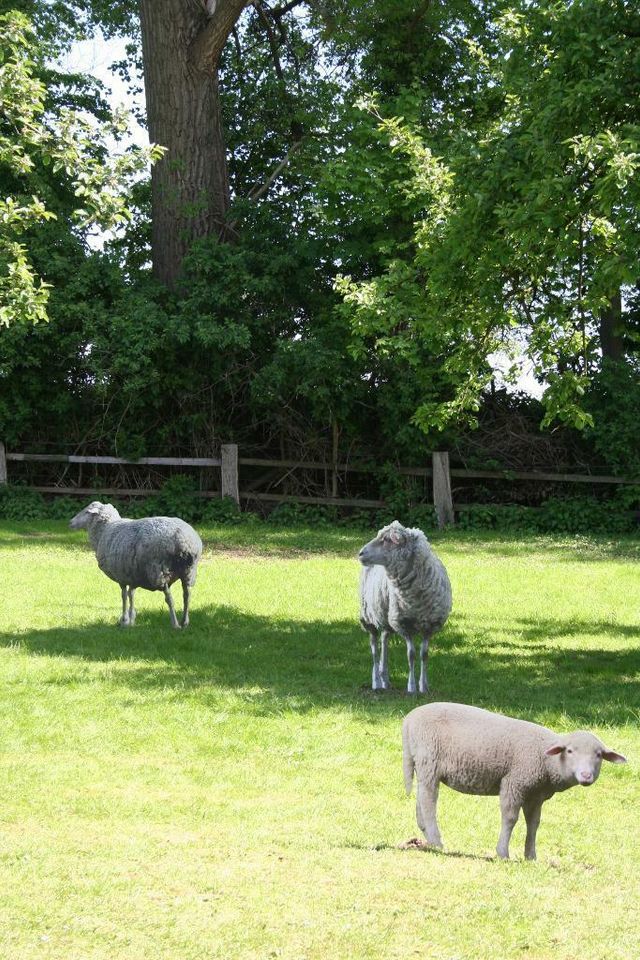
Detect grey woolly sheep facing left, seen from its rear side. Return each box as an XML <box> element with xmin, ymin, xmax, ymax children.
<box><xmin>69</xmin><ymin>500</ymin><xmax>202</xmax><ymax>628</ymax></box>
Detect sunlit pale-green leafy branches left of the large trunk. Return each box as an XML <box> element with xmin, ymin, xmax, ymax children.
<box><xmin>0</xmin><ymin>12</ymin><xmax>161</xmax><ymax>326</ymax></box>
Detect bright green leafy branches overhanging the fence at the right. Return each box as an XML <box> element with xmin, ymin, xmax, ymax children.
<box><xmin>340</xmin><ymin>0</ymin><xmax>640</xmax><ymax>430</ymax></box>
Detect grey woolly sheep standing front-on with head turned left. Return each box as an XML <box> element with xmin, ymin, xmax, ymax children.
<box><xmin>358</xmin><ymin>520</ymin><xmax>451</xmax><ymax>693</ymax></box>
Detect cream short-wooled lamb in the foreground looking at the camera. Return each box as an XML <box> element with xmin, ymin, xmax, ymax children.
<box><xmin>402</xmin><ymin>703</ymin><xmax>626</xmax><ymax>860</ymax></box>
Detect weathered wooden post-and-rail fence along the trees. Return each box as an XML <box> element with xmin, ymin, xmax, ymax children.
<box><xmin>0</xmin><ymin>442</ymin><xmax>638</xmax><ymax>527</ymax></box>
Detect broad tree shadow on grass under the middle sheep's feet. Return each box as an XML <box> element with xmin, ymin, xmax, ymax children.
<box><xmin>0</xmin><ymin>606</ymin><xmax>640</xmax><ymax>726</ymax></box>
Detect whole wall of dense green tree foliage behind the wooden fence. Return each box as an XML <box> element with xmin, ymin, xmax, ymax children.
<box><xmin>0</xmin><ymin>0</ymin><xmax>640</xmax><ymax>480</ymax></box>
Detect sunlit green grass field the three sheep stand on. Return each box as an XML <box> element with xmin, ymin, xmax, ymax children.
<box><xmin>0</xmin><ymin>523</ymin><xmax>640</xmax><ymax>960</ymax></box>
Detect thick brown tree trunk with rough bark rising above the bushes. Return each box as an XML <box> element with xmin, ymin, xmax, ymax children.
<box><xmin>140</xmin><ymin>0</ymin><xmax>246</xmax><ymax>287</ymax></box>
